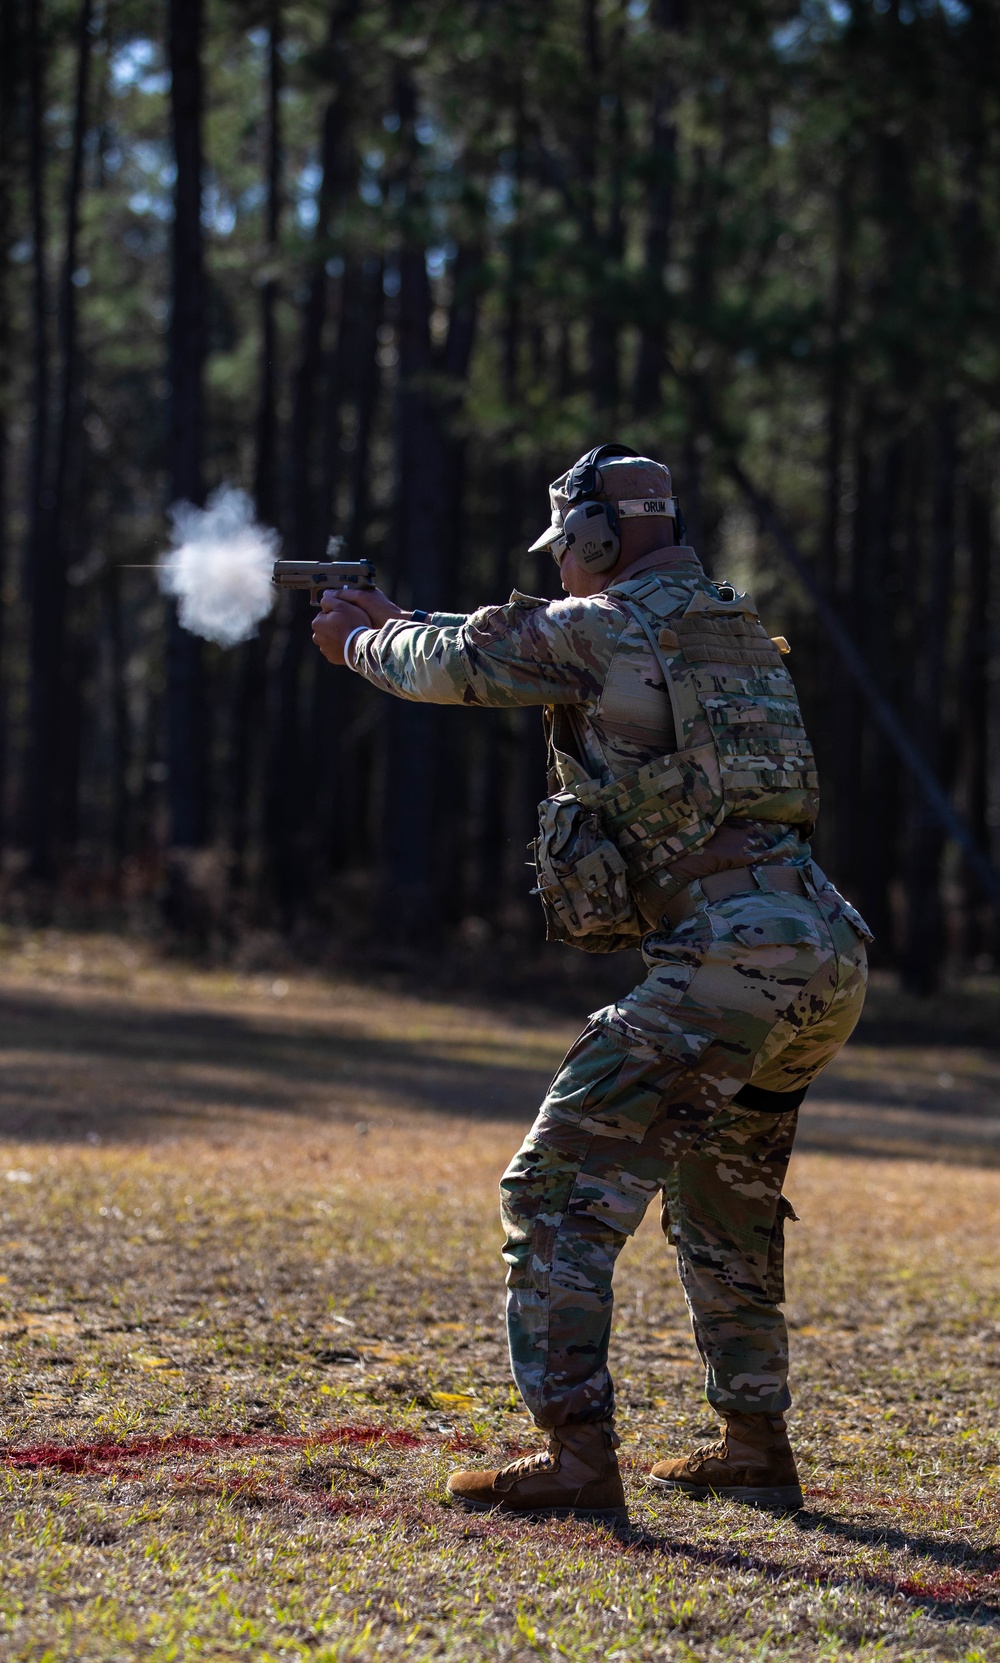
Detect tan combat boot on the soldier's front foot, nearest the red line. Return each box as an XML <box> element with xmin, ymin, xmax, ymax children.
<box><xmin>448</xmin><ymin>1420</ymin><xmax>629</xmax><ymax>1523</ymax></box>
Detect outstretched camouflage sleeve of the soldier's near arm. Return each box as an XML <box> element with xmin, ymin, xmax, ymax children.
<box><xmin>351</xmin><ymin>595</ymin><xmax>626</xmax><ymax>707</ymax></box>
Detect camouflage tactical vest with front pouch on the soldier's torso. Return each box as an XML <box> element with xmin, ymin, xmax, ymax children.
<box><xmin>536</xmin><ymin>572</ymin><xmax>819</xmax><ymax>953</ymax></box>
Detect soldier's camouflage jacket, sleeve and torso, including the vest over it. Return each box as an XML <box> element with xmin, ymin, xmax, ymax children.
<box><xmin>354</xmin><ymin>547</ymin><xmax>819</xmax><ymax>923</ymax></box>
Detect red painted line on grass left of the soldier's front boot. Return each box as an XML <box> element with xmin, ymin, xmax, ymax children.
<box><xmin>0</xmin><ymin>1425</ymin><xmax>428</xmax><ymax>1473</ymax></box>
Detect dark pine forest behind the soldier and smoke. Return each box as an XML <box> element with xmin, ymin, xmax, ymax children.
<box><xmin>0</xmin><ymin>0</ymin><xmax>1000</xmax><ymax>991</ymax></box>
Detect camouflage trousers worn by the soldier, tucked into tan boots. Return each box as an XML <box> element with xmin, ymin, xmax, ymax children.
<box><xmin>501</xmin><ymin>885</ymin><xmax>867</xmax><ymax>1427</ymax></box>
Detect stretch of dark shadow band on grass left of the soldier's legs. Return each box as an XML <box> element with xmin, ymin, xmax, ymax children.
<box><xmin>0</xmin><ymin>993</ymin><xmax>549</xmax><ymax>1139</ymax></box>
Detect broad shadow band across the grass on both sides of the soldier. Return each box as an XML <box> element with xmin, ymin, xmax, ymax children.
<box><xmin>0</xmin><ymin>989</ymin><xmax>1000</xmax><ymax>1166</ymax></box>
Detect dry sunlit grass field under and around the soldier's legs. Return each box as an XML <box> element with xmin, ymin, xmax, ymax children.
<box><xmin>0</xmin><ymin>931</ymin><xmax>1000</xmax><ymax>1663</ymax></box>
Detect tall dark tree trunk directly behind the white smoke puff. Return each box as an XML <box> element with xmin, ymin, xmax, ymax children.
<box><xmin>166</xmin><ymin>0</ymin><xmax>210</xmax><ymax>891</ymax></box>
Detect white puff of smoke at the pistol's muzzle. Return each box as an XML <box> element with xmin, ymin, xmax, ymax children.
<box><xmin>158</xmin><ymin>486</ymin><xmax>281</xmax><ymax>647</ymax></box>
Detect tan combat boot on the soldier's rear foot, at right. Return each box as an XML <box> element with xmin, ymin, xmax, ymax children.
<box><xmin>649</xmin><ymin>1410</ymin><xmax>802</xmax><ymax>1512</ymax></box>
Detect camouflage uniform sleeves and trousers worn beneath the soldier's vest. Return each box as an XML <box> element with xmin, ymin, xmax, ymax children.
<box><xmin>354</xmin><ymin>547</ymin><xmax>867</xmax><ymax>1427</ymax></box>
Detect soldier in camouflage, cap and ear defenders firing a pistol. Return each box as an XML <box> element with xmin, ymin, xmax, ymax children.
<box><xmin>313</xmin><ymin>444</ymin><xmax>870</xmax><ymax>1518</ymax></box>
